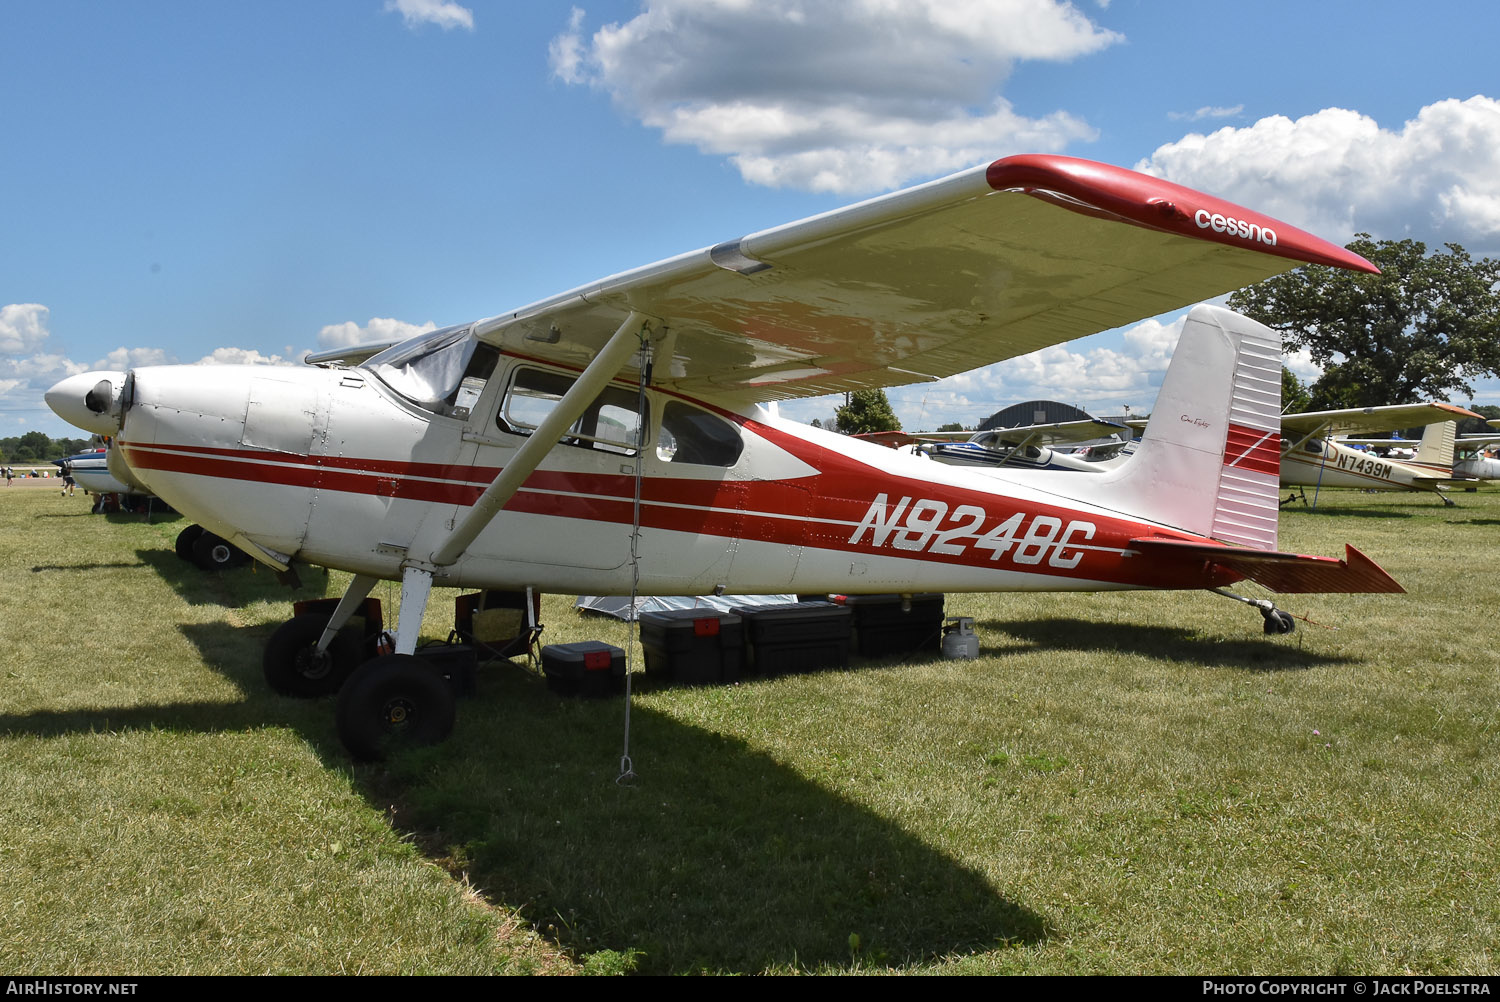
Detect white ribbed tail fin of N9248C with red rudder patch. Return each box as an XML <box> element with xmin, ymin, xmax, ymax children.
<box><xmin>1101</xmin><ymin>306</ymin><xmax>1281</xmax><ymax>551</ymax></box>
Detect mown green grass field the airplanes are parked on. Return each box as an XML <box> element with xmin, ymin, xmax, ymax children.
<box><xmin>0</xmin><ymin>492</ymin><xmax>1500</xmax><ymax>974</ymax></box>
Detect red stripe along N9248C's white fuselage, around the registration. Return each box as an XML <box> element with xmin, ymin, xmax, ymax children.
<box><xmin>123</xmin><ymin>423</ymin><xmax>1223</xmax><ymax>588</ymax></box>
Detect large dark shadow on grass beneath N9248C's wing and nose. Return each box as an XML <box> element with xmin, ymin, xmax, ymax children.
<box><xmin>0</xmin><ymin>621</ymin><xmax>1049</xmax><ymax>974</ymax></box>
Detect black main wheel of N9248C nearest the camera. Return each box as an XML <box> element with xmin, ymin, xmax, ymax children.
<box><xmin>335</xmin><ymin>654</ymin><xmax>456</xmax><ymax>761</ymax></box>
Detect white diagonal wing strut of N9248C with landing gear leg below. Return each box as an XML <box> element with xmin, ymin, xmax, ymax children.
<box><xmin>384</xmin><ymin>311</ymin><xmax>650</xmax><ymax>654</ymax></box>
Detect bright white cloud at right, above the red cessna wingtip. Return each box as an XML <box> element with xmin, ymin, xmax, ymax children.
<box><xmin>1137</xmin><ymin>96</ymin><xmax>1500</xmax><ymax>255</ymax></box>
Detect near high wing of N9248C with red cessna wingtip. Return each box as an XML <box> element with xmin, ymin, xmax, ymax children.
<box><xmin>476</xmin><ymin>156</ymin><xmax>1376</xmax><ymax>402</ymax></box>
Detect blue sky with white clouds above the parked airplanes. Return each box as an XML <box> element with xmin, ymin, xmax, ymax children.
<box><xmin>0</xmin><ymin>0</ymin><xmax>1500</xmax><ymax>437</ymax></box>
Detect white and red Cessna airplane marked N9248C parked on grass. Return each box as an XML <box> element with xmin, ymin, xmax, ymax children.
<box><xmin>47</xmin><ymin>156</ymin><xmax>1401</xmax><ymax>750</ymax></box>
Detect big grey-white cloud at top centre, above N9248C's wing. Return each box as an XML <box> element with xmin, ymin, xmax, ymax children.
<box><xmin>549</xmin><ymin>0</ymin><xmax>1121</xmax><ymax>194</ymax></box>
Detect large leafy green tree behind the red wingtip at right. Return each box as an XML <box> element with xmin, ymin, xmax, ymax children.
<box><xmin>1229</xmin><ymin>233</ymin><xmax>1500</xmax><ymax>408</ymax></box>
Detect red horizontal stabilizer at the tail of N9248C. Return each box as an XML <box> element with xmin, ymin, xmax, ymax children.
<box><xmin>1130</xmin><ymin>539</ymin><xmax>1406</xmax><ymax>594</ymax></box>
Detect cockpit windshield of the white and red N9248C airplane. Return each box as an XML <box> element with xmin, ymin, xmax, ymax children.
<box><xmin>360</xmin><ymin>324</ymin><xmax>500</xmax><ymax>420</ymax></box>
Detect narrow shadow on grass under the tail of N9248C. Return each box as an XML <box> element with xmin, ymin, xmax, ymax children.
<box><xmin>984</xmin><ymin>617</ymin><xmax>1358</xmax><ymax>672</ymax></box>
